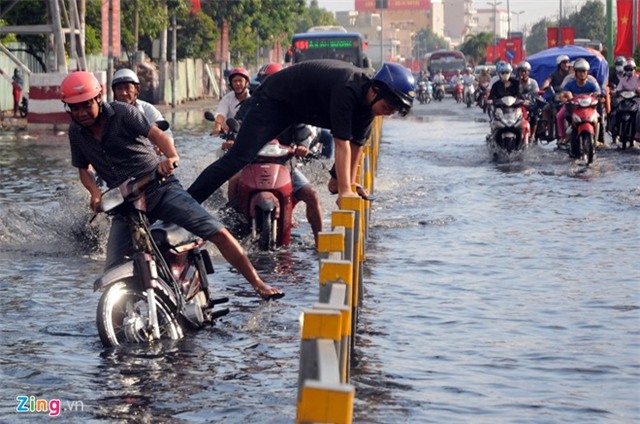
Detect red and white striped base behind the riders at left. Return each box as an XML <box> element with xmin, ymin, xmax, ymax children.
<box><xmin>27</xmin><ymin>71</ymin><xmax>107</xmax><ymax>128</ymax></box>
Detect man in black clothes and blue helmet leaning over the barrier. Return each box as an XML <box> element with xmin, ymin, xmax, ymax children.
<box><xmin>188</xmin><ymin>59</ymin><xmax>415</xmax><ymax>208</ymax></box>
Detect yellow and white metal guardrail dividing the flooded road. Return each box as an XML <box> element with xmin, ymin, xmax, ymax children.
<box><xmin>296</xmin><ymin>118</ymin><xmax>382</xmax><ymax>424</ymax></box>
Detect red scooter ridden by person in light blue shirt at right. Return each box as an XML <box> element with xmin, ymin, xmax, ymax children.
<box><xmin>567</xmin><ymin>94</ymin><xmax>600</xmax><ymax>165</ymax></box>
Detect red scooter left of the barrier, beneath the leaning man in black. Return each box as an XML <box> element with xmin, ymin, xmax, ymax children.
<box><xmin>205</xmin><ymin>114</ymin><xmax>297</xmax><ymax>250</ymax></box>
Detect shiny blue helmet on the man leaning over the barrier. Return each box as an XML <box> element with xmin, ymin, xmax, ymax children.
<box><xmin>373</xmin><ymin>63</ymin><xmax>416</xmax><ymax>116</ymax></box>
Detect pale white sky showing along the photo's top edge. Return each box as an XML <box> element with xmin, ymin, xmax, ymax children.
<box><xmin>318</xmin><ymin>0</ymin><xmax>605</xmax><ymax>27</ymax></box>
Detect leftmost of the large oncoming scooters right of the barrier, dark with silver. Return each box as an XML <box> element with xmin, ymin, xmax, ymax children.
<box><xmin>487</xmin><ymin>96</ymin><xmax>526</xmax><ymax>159</ymax></box>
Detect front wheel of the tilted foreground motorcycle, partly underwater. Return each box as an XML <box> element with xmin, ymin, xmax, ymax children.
<box><xmin>96</xmin><ymin>281</ymin><xmax>182</xmax><ymax>347</ymax></box>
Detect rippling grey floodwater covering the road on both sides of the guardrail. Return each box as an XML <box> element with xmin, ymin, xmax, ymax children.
<box><xmin>0</xmin><ymin>105</ymin><xmax>640</xmax><ymax>423</ymax></box>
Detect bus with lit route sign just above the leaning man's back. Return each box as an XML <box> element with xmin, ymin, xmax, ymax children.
<box><xmin>285</xmin><ymin>27</ymin><xmax>370</xmax><ymax>68</ymax></box>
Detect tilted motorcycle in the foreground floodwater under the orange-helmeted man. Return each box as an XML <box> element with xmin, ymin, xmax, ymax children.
<box><xmin>93</xmin><ymin>167</ymin><xmax>229</xmax><ymax>347</ymax></box>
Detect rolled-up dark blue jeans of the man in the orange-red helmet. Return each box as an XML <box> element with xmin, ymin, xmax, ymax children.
<box><xmin>105</xmin><ymin>178</ymin><xmax>224</xmax><ymax>269</ymax></box>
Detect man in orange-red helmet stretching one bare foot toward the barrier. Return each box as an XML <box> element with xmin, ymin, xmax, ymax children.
<box><xmin>60</xmin><ymin>71</ymin><xmax>283</xmax><ymax>299</ymax></box>
